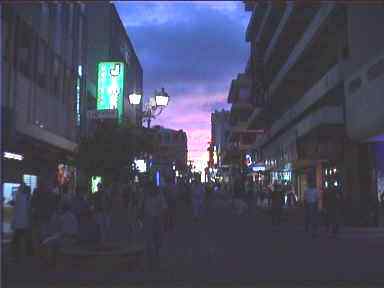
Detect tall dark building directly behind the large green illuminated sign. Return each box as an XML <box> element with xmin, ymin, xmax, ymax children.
<box><xmin>85</xmin><ymin>1</ymin><xmax>143</xmax><ymax>127</ymax></box>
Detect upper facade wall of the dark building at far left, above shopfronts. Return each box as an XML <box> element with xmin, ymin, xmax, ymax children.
<box><xmin>2</xmin><ymin>3</ymin><xmax>78</xmax><ymax>150</ymax></box>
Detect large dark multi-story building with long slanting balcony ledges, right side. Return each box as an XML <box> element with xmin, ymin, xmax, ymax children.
<box><xmin>240</xmin><ymin>1</ymin><xmax>384</xmax><ymax>222</ymax></box>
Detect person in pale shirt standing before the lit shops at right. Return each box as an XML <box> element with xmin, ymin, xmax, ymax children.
<box><xmin>304</xmin><ymin>177</ymin><xmax>319</xmax><ymax>237</ymax></box>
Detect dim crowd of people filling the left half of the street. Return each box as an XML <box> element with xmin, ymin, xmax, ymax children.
<box><xmin>10</xmin><ymin>174</ymin><xmax>201</xmax><ymax>269</ymax></box>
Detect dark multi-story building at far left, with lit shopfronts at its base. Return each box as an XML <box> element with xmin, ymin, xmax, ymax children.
<box><xmin>1</xmin><ymin>1</ymin><xmax>87</xmax><ymax>193</ymax></box>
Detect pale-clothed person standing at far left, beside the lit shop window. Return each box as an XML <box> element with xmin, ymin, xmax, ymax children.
<box><xmin>12</xmin><ymin>183</ymin><xmax>33</xmax><ymax>262</ymax></box>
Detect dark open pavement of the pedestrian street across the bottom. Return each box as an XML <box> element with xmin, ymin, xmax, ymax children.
<box><xmin>3</xmin><ymin>203</ymin><xmax>384</xmax><ymax>287</ymax></box>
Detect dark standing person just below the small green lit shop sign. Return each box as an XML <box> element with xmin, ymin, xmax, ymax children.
<box><xmin>94</xmin><ymin>183</ymin><xmax>112</xmax><ymax>243</ymax></box>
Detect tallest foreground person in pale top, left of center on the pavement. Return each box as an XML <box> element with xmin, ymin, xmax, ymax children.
<box><xmin>142</xmin><ymin>181</ymin><xmax>167</xmax><ymax>271</ymax></box>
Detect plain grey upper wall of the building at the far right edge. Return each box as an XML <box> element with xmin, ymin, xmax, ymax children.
<box><xmin>344</xmin><ymin>4</ymin><xmax>384</xmax><ymax>141</ymax></box>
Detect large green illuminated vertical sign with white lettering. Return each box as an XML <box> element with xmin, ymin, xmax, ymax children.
<box><xmin>97</xmin><ymin>62</ymin><xmax>125</xmax><ymax>120</ymax></box>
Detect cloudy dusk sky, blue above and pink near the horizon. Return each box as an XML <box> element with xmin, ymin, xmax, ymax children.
<box><xmin>115</xmin><ymin>1</ymin><xmax>250</xmax><ymax>168</ymax></box>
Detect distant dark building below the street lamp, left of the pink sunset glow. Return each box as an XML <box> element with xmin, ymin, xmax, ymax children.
<box><xmin>151</xmin><ymin>126</ymin><xmax>188</xmax><ymax>184</ymax></box>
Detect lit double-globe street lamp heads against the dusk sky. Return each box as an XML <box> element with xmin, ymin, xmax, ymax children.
<box><xmin>129</xmin><ymin>88</ymin><xmax>169</xmax><ymax>128</ymax></box>
